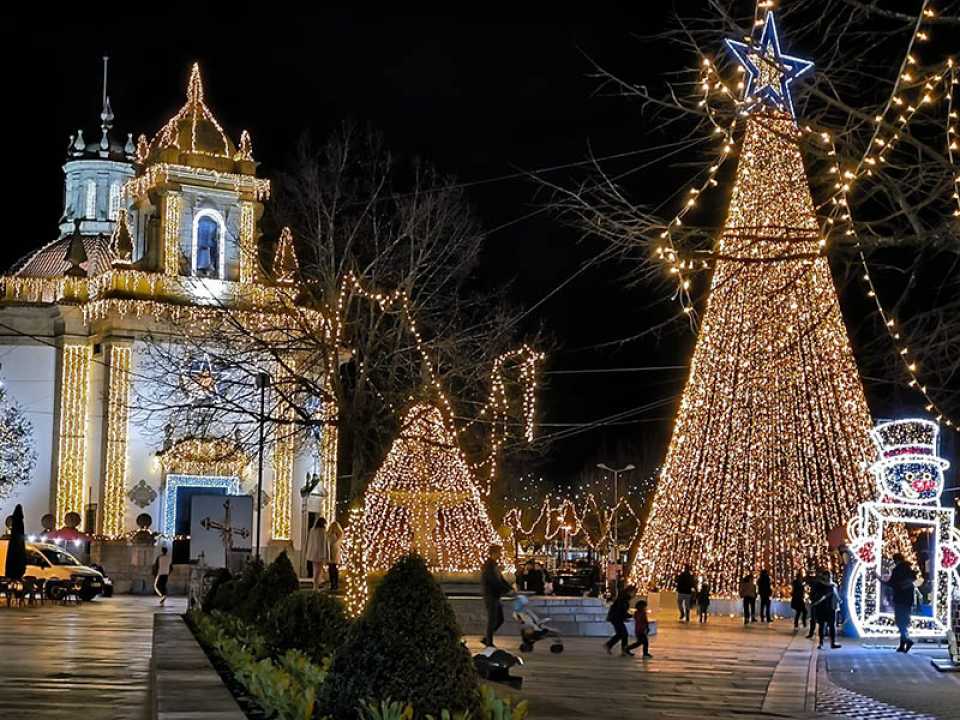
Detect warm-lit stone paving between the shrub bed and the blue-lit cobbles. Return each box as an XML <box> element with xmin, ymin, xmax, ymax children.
<box><xmin>470</xmin><ymin>618</ymin><xmax>806</xmax><ymax>720</ymax></box>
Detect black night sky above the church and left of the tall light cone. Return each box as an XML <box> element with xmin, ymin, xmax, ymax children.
<box><xmin>0</xmin><ymin>9</ymin><xmax>944</xmax><ymax>478</ymax></box>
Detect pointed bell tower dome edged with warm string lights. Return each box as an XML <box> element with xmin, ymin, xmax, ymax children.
<box><xmin>141</xmin><ymin>63</ymin><xmax>248</xmax><ymax>172</ymax></box>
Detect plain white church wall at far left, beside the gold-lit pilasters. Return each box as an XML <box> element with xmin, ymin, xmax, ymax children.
<box><xmin>0</xmin><ymin>344</ymin><xmax>56</xmax><ymax>533</ymax></box>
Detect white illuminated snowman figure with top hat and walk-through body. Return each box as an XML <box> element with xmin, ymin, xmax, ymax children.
<box><xmin>847</xmin><ymin>419</ymin><xmax>960</xmax><ymax>637</ymax></box>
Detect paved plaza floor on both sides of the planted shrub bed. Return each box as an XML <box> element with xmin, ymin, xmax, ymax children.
<box><xmin>0</xmin><ymin>596</ymin><xmax>960</xmax><ymax>720</ymax></box>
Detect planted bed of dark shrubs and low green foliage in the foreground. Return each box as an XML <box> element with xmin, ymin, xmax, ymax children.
<box><xmin>188</xmin><ymin>555</ymin><xmax>527</xmax><ymax>720</ymax></box>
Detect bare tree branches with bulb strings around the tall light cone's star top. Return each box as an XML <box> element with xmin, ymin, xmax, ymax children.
<box><xmin>544</xmin><ymin>0</ymin><xmax>960</xmax><ymax>412</ymax></box>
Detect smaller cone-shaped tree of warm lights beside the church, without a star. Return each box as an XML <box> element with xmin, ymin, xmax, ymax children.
<box><xmin>350</xmin><ymin>403</ymin><xmax>502</xmax><ymax>573</ymax></box>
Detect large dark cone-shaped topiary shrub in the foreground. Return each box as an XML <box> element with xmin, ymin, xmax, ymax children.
<box><xmin>320</xmin><ymin>555</ymin><xmax>480</xmax><ymax>720</ymax></box>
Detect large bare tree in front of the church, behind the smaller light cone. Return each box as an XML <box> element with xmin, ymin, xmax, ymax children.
<box><xmin>138</xmin><ymin>126</ymin><xmax>544</xmax><ymax>506</ymax></box>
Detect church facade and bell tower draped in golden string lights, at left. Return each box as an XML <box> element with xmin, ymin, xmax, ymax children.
<box><xmin>0</xmin><ymin>66</ymin><xmax>337</xmax><ymax>564</ymax></box>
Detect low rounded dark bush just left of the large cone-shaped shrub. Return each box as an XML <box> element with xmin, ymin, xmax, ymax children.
<box><xmin>264</xmin><ymin>590</ymin><xmax>350</xmax><ymax>664</ymax></box>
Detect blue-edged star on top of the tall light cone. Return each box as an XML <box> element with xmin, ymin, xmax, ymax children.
<box><xmin>726</xmin><ymin>11</ymin><xmax>813</xmax><ymax>121</ymax></box>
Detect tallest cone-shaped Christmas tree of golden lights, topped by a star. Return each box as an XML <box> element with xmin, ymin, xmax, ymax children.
<box><xmin>633</xmin><ymin>15</ymin><xmax>872</xmax><ymax>595</ymax></box>
